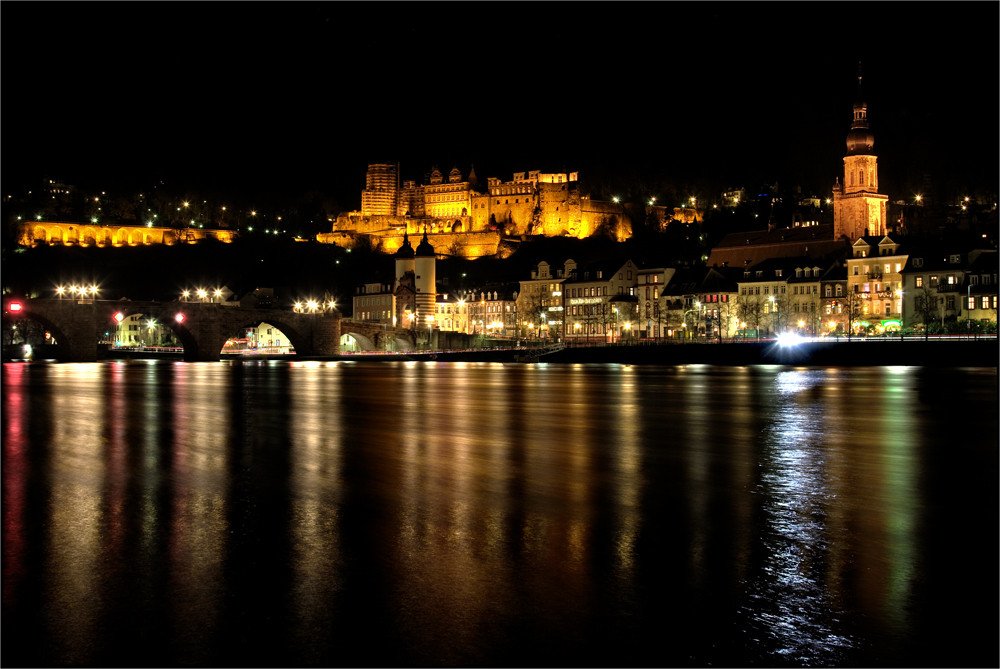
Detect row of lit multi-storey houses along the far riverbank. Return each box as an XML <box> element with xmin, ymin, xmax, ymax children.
<box><xmin>354</xmin><ymin>236</ymin><xmax>998</xmax><ymax>342</ymax></box>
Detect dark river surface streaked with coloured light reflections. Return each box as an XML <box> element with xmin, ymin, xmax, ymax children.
<box><xmin>0</xmin><ymin>361</ymin><xmax>1000</xmax><ymax>667</ymax></box>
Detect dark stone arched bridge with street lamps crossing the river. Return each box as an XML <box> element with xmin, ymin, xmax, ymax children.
<box><xmin>11</xmin><ymin>299</ymin><xmax>341</xmax><ymax>362</ymax></box>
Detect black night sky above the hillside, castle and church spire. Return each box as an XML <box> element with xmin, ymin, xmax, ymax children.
<box><xmin>0</xmin><ymin>2</ymin><xmax>1000</xmax><ymax>208</ymax></box>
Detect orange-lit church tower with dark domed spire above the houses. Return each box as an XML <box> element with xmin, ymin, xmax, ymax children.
<box><xmin>833</xmin><ymin>65</ymin><xmax>889</xmax><ymax>242</ymax></box>
